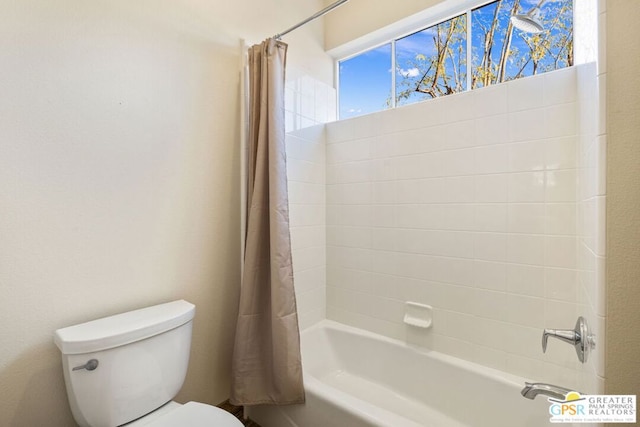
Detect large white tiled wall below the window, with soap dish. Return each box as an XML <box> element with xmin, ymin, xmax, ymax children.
<box><xmin>326</xmin><ymin>67</ymin><xmax>596</xmax><ymax>387</ymax></box>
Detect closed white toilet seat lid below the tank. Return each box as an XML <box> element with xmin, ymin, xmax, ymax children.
<box><xmin>127</xmin><ymin>402</ymin><xmax>242</xmax><ymax>427</ymax></box>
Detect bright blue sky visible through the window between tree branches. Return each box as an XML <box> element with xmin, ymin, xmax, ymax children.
<box><xmin>339</xmin><ymin>0</ymin><xmax>567</xmax><ymax>119</ymax></box>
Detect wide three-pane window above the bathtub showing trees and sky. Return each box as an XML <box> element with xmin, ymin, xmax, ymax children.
<box><xmin>338</xmin><ymin>0</ymin><xmax>573</xmax><ymax>119</ymax></box>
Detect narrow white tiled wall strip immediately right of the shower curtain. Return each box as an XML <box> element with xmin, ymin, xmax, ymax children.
<box><xmin>285</xmin><ymin>67</ymin><xmax>337</xmax><ymax>329</ymax></box>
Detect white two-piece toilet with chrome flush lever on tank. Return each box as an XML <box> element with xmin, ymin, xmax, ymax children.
<box><xmin>54</xmin><ymin>300</ymin><xmax>242</xmax><ymax>427</ymax></box>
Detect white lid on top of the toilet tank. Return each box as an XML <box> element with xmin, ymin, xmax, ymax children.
<box><xmin>54</xmin><ymin>300</ymin><xmax>195</xmax><ymax>354</ymax></box>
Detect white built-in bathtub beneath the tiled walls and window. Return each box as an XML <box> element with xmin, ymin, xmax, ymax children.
<box><xmin>247</xmin><ymin>320</ymin><xmax>550</xmax><ymax>427</ymax></box>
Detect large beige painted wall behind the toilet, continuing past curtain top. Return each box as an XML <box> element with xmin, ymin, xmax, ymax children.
<box><xmin>0</xmin><ymin>0</ymin><xmax>332</xmax><ymax>427</ymax></box>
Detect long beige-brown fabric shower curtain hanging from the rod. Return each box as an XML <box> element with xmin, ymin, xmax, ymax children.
<box><xmin>230</xmin><ymin>39</ymin><xmax>304</xmax><ymax>405</ymax></box>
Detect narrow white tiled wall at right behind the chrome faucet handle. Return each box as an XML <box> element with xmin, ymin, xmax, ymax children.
<box><xmin>577</xmin><ymin>1</ymin><xmax>607</xmax><ymax>393</ymax></box>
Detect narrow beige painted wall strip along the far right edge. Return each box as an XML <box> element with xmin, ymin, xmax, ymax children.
<box><xmin>605</xmin><ymin>0</ymin><xmax>640</xmax><ymax>398</ymax></box>
